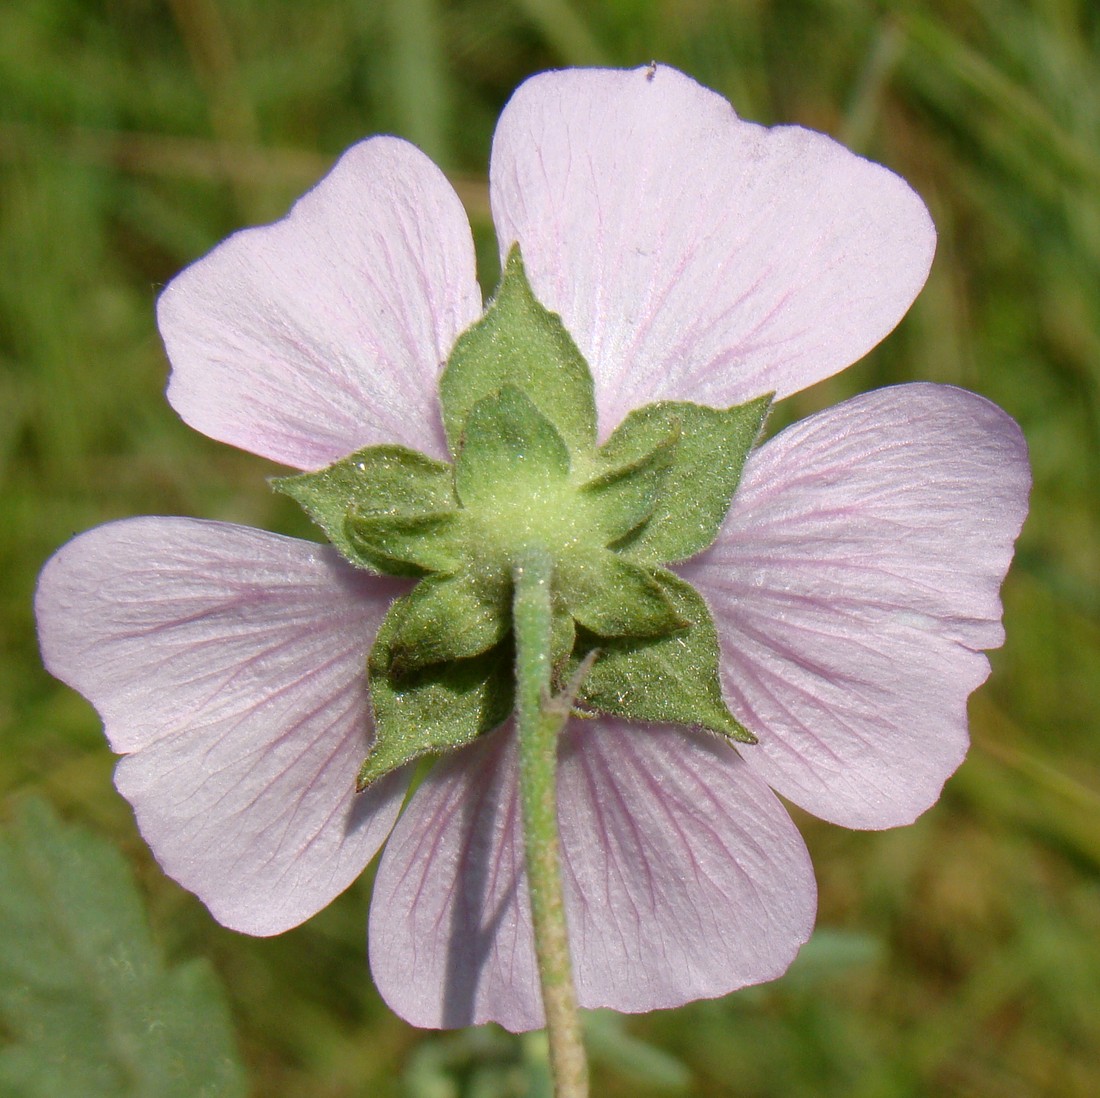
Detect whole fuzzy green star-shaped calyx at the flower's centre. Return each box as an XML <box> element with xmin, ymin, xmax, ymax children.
<box><xmin>274</xmin><ymin>246</ymin><xmax>771</xmax><ymax>788</ymax></box>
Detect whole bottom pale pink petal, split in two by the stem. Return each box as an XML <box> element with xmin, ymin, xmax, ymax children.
<box><xmin>371</xmin><ymin>720</ymin><xmax>816</xmax><ymax>1031</ymax></box>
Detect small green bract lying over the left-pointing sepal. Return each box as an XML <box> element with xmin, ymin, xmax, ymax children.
<box><xmin>344</xmin><ymin>508</ymin><xmax>462</xmax><ymax>575</ymax></box>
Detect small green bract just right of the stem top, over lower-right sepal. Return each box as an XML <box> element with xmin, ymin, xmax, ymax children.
<box><xmin>556</xmin><ymin>549</ymin><xmax>691</xmax><ymax>637</ymax></box>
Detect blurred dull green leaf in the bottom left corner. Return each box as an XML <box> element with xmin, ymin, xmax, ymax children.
<box><xmin>0</xmin><ymin>800</ymin><xmax>246</xmax><ymax>1098</ymax></box>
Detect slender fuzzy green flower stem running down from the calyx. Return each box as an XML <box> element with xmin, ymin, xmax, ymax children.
<box><xmin>513</xmin><ymin>547</ymin><xmax>589</xmax><ymax>1098</ymax></box>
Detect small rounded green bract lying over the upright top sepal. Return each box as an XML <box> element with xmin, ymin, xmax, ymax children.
<box><xmin>454</xmin><ymin>385</ymin><xmax>571</xmax><ymax>512</ymax></box>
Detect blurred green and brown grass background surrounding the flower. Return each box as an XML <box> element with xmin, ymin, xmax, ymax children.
<box><xmin>0</xmin><ymin>0</ymin><xmax>1100</xmax><ymax>1098</ymax></box>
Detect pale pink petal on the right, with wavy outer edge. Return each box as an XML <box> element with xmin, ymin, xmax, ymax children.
<box><xmin>677</xmin><ymin>384</ymin><xmax>1030</xmax><ymax>827</ymax></box>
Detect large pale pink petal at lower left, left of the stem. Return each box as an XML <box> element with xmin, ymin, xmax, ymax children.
<box><xmin>35</xmin><ymin>518</ymin><xmax>407</xmax><ymax>934</ymax></box>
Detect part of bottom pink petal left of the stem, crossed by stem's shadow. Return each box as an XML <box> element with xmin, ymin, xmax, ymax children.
<box><xmin>370</xmin><ymin>725</ymin><xmax>542</xmax><ymax>1032</ymax></box>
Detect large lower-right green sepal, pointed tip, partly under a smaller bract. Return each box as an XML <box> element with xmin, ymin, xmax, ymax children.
<box><xmin>571</xmin><ymin>569</ymin><xmax>756</xmax><ymax>744</ymax></box>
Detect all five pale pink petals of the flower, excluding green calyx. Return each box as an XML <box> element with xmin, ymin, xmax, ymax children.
<box><xmin>36</xmin><ymin>66</ymin><xmax>1029</xmax><ymax>1030</ymax></box>
